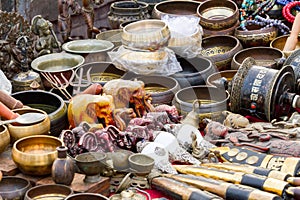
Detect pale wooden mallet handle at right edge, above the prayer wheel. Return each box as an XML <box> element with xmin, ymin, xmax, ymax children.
<box><xmin>283</xmin><ymin>13</ymin><xmax>300</xmax><ymax>51</ymax></box>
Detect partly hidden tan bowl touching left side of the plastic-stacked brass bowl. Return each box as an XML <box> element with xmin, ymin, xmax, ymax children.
<box><xmin>96</xmin><ymin>29</ymin><xmax>123</xmax><ymax>47</ymax></box>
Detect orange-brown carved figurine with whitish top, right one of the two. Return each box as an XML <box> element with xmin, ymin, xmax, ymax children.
<box><xmin>103</xmin><ymin>79</ymin><xmax>154</xmax><ymax>130</ymax></box>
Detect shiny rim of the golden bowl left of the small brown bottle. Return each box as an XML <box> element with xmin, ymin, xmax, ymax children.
<box><xmin>12</xmin><ymin>135</ymin><xmax>64</xmax><ymax>156</ymax></box>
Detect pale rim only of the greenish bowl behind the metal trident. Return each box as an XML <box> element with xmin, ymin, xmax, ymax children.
<box><xmin>31</xmin><ymin>51</ymin><xmax>85</xmax><ymax>73</ymax></box>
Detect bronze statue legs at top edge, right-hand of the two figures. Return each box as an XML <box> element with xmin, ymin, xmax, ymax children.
<box><xmin>82</xmin><ymin>0</ymin><xmax>103</xmax><ymax>38</ymax></box>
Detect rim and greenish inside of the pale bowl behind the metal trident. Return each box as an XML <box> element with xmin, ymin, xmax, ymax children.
<box><xmin>31</xmin><ymin>52</ymin><xmax>84</xmax><ymax>72</ymax></box>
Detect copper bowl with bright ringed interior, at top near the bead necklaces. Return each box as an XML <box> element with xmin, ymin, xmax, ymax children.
<box><xmin>197</xmin><ymin>0</ymin><xmax>239</xmax><ymax>30</ymax></box>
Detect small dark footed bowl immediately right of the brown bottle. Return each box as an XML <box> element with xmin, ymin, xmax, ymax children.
<box><xmin>75</xmin><ymin>152</ymin><xmax>107</xmax><ymax>183</ymax></box>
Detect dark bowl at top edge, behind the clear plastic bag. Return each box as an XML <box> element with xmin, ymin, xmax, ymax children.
<box><xmin>152</xmin><ymin>0</ymin><xmax>201</xmax><ymax>19</ymax></box>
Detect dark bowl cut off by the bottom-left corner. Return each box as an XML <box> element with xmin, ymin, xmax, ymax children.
<box><xmin>0</xmin><ymin>176</ymin><xmax>31</xmax><ymax>200</ymax></box>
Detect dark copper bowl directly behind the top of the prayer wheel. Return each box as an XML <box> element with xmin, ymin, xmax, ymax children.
<box><xmin>231</xmin><ymin>47</ymin><xmax>285</xmax><ymax>70</ymax></box>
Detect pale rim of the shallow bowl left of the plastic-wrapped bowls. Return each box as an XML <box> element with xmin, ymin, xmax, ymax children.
<box><xmin>62</xmin><ymin>39</ymin><xmax>115</xmax><ymax>54</ymax></box>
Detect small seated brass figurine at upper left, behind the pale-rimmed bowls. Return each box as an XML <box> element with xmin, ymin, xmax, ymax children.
<box><xmin>31</xmin><ymin>15</ymin><xmax>61</xmax><ymax>56</ymax></box>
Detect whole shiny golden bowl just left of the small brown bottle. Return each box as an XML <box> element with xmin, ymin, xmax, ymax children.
<box><xmin>12</xmin><ymin>135</ymin><xmax>63</xmax><ymax>176</ymax></box>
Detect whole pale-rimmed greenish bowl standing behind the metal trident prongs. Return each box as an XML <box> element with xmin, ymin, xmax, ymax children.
<box><xmin>31</xmin><ymin>52</ymin><xmax>84</xmax><ymax>89</ymax></box>
